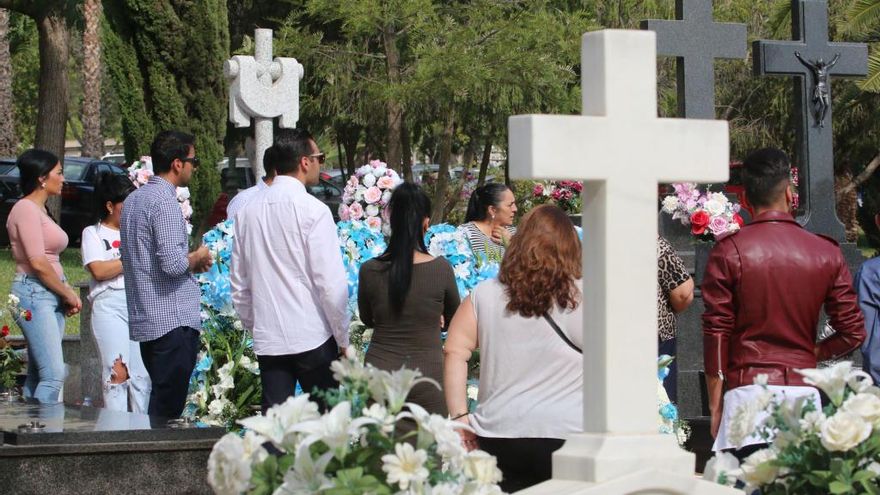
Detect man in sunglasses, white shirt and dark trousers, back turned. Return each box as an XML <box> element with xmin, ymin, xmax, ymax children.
<box><xmin>231</xmin><ymin>129</ymin><xmax>349</xmax><ymax>412</ymax></box>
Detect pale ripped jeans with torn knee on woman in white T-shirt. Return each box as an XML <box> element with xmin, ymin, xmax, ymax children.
<box><xmin>92</xmin><ymin>288</ymin><xmax>151</xmax><ymax>414</ymax></box>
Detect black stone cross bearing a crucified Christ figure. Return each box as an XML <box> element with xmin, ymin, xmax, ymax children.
<box><xmin>752</xmin><ymin>0</ymin><xmax>868</xmax><ymax>242</ymax></box>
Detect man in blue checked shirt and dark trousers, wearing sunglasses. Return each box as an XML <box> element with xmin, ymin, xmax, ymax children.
<box><xmin>120</xmin><ymin>131</ymin><xmax>212</xmax><ymax>418</ymax></box>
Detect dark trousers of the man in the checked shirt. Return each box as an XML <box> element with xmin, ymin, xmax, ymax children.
<box><xmin>141</xmin><ymin>327</ymin><xmax>199</xmax><ymax>419</ymax></box>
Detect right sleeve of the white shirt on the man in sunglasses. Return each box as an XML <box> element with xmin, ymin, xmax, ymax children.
<box><xmin>308</xmin><ymin>207</ymin><xmax>348</xmax><ymax>347</ymax></box>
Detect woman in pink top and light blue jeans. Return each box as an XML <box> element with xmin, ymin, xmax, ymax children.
<box><xmin>6</xmin><ymin>150</ymin><xmax>82</xmax><ymax>403</ymax></box>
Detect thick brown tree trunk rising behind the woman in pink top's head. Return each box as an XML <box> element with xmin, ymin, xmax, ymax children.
<box><xmin>34</xmin><ymin>9</ymin><xmax>70</xmax><ymax>221</ymax></box>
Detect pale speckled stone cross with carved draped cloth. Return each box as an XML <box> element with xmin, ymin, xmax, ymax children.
<box><xmin>223</xmin><ymin>29</ymin><xmax>304</xmax><ymax>180</ymax></box>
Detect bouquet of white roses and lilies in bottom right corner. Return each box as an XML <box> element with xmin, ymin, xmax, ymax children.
<box><xmin>703</xmin><ymin>361</ymin><xmax>880</xmax><ymax>495</ymax></box>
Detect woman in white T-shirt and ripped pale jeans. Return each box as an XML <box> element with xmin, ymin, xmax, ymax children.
<box><xmin>82</xmin><ymin>173</ymin><xmax>151</xmax><ymax>414</ymax></box>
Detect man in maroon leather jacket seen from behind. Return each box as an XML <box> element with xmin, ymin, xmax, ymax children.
<box><xmin>702</xmin><ymin>148</ymin><xmax>865</xmax><ymax>437</ymax></box>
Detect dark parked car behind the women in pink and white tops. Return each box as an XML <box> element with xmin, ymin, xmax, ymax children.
<box><xmin>0</xmin><ymin>156</ymin><xmax>128</xmax><ymax>246</ymax></box>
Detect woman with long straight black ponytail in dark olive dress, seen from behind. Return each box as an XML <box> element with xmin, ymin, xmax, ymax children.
<box><xmin>358</xmin><ymin>183</ymin><xmax>459</xmax><ymax>415</ymax></box>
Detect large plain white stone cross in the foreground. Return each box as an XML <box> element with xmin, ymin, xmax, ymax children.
<box><xmin>508</xmin><ymin>30</ymin><xmax>736</xmax><ymax>495</ymax></box>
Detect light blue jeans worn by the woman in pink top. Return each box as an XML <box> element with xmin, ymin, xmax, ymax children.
<box><xmin>12</xmin><ymin>273</ymin><xmax>67</xmax><ymax>404</ymax></box>
